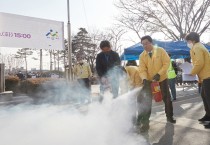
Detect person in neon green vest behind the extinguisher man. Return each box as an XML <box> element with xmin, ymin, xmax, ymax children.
<box><xmin>168</xmin><ymin>54</ymin><xmax>176</xmax><ymax>100</ymax></box>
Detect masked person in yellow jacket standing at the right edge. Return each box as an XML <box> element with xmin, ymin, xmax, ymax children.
<box><xmin>185</xmin><ymin>32</ymin><xmax>210</xmax><ymax>128</ymax></box>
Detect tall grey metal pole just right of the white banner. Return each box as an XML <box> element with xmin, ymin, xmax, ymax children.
<box><xmin>67</xmin><ymin>0</ymin><xmax>73</xmax><ymax>81</ymax></box>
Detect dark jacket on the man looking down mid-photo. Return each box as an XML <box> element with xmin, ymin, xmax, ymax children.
<box><xmin>96</xmin><ymin>50</ymin><xmax>120</xmax><ymax>77</ymax></box>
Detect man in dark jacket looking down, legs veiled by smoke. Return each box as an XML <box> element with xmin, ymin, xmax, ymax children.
<box><xmin>96</xmin><ymin>40</ymin><xmax>121</xmax><ymax>99</ymax></box>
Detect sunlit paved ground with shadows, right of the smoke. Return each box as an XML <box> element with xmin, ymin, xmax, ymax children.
<box><xmin>148</xmin><ymin>87</ymin><xmax>210</xmax><ymax>145</ymax></box>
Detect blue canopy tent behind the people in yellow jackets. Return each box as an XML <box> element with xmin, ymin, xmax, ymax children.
<box><xmin>121</xmin><ymin>40</ymin><xmax>210</xmax><ymax>60</ymax></box>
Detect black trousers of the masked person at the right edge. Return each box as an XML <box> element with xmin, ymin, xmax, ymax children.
<box><xmin>201</xmin><ymin>78</ymin><xmax>210</xmax><ymax>117</ymax></box>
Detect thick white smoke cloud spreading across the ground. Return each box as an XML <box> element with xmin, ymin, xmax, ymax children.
<box><xmin>0</xmin><ymin>81</ymin><xmax>148</xmax><ymax>145</ymax></box>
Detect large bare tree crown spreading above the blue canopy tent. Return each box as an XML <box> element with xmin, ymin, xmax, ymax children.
<box><xmin>116</xmin><ymin>0</ymin><xmax>210</xmax><ymax>40</ymax></box>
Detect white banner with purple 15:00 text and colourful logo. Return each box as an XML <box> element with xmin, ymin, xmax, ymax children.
<box><xmin>0</xmin><ymin>12</ymin><xmax>64</xmax><ymax>50</ymax></box>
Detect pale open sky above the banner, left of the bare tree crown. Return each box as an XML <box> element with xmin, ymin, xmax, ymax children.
<box><xmin>0</xmin><ymin>0</ymin><xmax>117</xmax><ymax>33</ymax></box>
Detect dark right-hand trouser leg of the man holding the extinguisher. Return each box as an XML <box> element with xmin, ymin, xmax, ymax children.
<box><xmin>160</xmin><ymin>79</ymin><xmax>173</xmax><ymax>118</ymax></box>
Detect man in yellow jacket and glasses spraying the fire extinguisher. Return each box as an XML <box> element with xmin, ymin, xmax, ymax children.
<box><xmin>139</xmin><ymin>36</ymin><xmax>176</xmax><ymax>123</ymax></box>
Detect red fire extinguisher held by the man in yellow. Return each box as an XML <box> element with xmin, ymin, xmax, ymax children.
<box><xmin>151</xmin><ymin>81</ymin><xmax>162</xmax><ymax>102</ymax></box>
